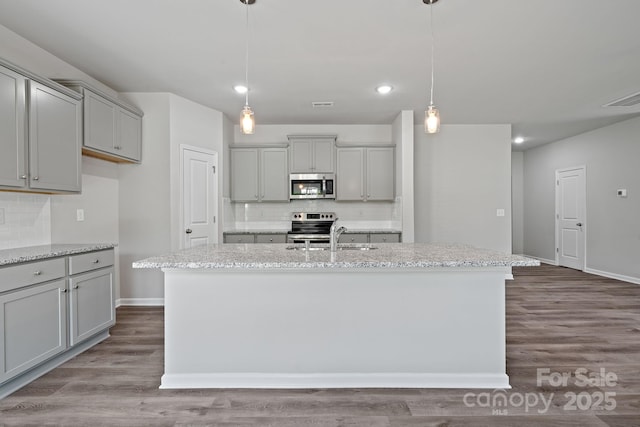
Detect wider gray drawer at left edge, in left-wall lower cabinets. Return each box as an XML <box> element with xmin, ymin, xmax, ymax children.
<box><xmin>0</xmin><ymin>258</ymin><xmax>65</xmax><ymax>292</ymax></box>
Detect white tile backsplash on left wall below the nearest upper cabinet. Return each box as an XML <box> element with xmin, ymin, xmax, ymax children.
<box><xmin>0</xmin><ymin>192</ymin><xmax>51</xmax><ymax>249</ymax></box>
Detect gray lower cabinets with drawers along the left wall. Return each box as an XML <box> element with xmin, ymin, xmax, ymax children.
<box><xmin>0</xmin><ymin>249</ymin><xmax>115</xmax><ymax>391</ymax></box>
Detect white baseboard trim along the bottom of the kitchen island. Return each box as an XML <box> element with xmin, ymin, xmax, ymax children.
<box><xmin>160</xmin><ymin>372</ymin><xmax>511</xmax><ymax>389</ymax></box>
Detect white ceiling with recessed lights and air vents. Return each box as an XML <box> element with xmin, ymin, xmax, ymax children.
<box><xmin>0</xmin><ymin>0</ymin><xmax>640</xmax><ymax>149</ymax></box>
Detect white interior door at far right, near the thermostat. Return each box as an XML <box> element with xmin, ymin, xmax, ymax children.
<box><xmin>556</xmin><ymin>167</ymin><xmax>586</xmax><ymax>270</ymax></box>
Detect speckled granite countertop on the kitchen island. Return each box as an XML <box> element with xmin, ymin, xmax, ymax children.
<box><xmin>133</xmin><ymin>243</ymin><xmax>540</xmax><ymax>270</ymax></box>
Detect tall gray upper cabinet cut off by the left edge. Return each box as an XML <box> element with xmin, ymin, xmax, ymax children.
<box><xmin>0</xmin><ymin>62</ymin><xmax>82</xmax><ymax>193</ymax></box>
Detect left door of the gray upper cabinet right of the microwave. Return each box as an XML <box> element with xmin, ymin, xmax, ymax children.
<box><xmin>336</xmin><ymin>148</ymin><xmax>364</xmax><ymax>201</ymax></box>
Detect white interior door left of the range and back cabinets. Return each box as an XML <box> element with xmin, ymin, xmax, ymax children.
<box><xmin>180</xmin><ymin>145</ymin><xmax>218</xmax><ymax>248</ymax></box>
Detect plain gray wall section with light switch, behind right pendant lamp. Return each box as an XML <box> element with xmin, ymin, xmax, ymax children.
<box><xmin>414</xmin><ymin>125</ymin><xmax>511</xmax><ymax>253</ymax></box>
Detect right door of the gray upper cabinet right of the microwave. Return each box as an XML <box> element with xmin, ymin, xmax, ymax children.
<box><xmin>366</xmin><ymin>147</ymin><xmax>395</xmax><ymax>200</ymax></box>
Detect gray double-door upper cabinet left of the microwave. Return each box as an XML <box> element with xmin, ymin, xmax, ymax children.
<box><xmin>230</xmin><ymin>147</ymin><xmax>289</xmax><ymax>202</ymax></box>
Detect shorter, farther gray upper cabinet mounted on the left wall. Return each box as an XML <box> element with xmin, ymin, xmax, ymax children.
<box><xmin>59</xmin><ymin>80</ymin><xmax>143</xmax><ymax>163</ymax></box>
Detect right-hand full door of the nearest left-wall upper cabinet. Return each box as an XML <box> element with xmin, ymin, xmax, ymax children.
<box><xmin>28</xmin><ymin>81</ymin><xmax>82</xmax><ymax>192</ymax></box>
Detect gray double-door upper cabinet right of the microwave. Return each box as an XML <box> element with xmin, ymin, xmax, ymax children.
<box><xmin>336</xmin><ymin>146</ymin><xmax>395</xmax><ymax>201</ymax></box>
